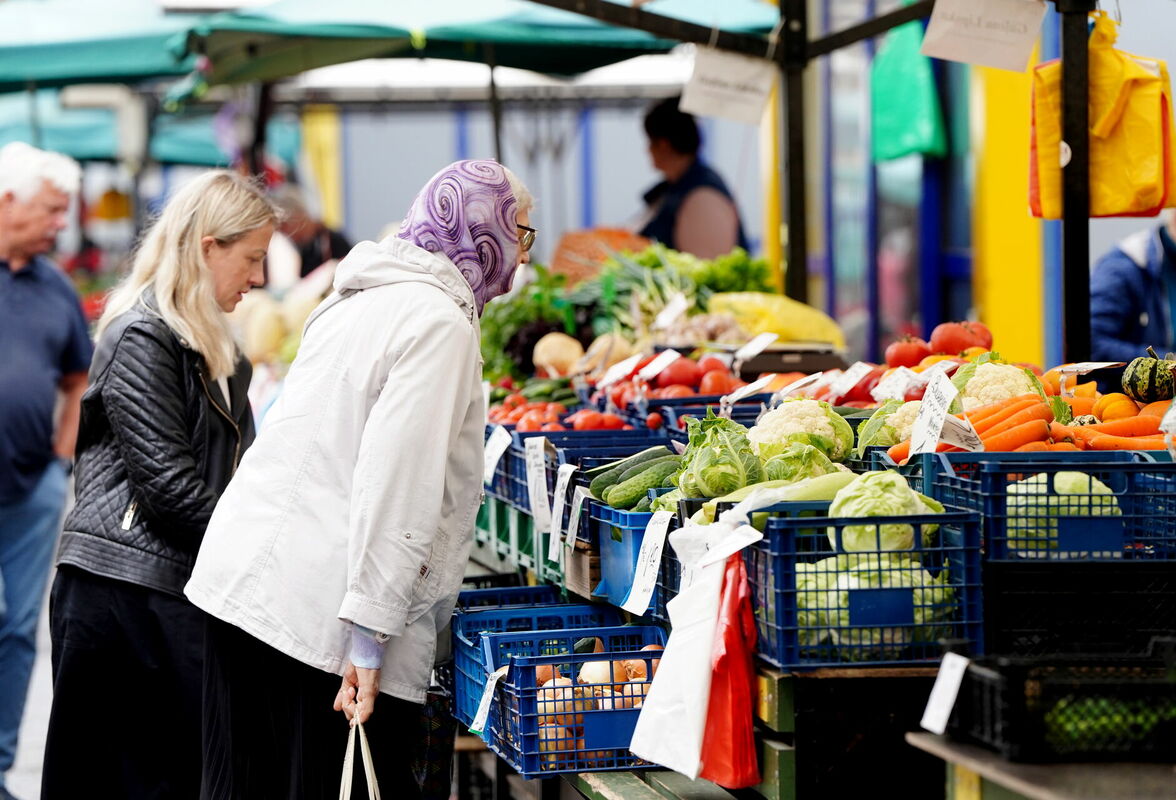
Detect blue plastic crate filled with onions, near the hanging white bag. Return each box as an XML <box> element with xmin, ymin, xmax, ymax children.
<box><xmin>482</xmin><ymin>626</ymin><xmax>666</xmax><ymax>778</ymax></box>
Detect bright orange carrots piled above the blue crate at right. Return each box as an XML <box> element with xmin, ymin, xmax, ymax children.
<box><xmin>887</xmin><ymin>394</ymin><xmax>1167</xmax><ymax>464</ymax></box>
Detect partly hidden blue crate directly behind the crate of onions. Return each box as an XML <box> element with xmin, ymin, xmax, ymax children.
<box><xmin>453</xmin><ymin>605</ymin><xmax>621</xmax><ymax>726</ymax></box>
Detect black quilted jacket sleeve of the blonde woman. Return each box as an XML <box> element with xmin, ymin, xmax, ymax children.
<box><xmin>102</xmin><ymin>322</ymin><xmax>216</xmax><ymax>536</ymax></box>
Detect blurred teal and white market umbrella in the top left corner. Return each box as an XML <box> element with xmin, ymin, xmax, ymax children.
<box><xmin>0</xmin><ymin>0</ymin><xmax>194</xmax><ymax>92</ymax></box>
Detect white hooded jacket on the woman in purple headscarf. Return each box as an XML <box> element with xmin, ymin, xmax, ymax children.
<box><xmin>185</xmin><ymin>238</ymin><xmax>486</xmax><ymax>702</ymax></box>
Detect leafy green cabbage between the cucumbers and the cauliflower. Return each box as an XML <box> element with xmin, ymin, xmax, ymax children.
<box><xmin>677</xmin><ymin>409</ymin><xmax>763</xmax><ymax>498</ymax></box>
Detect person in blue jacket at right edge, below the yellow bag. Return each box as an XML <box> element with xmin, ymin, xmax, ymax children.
<box><xmin>1090</xmin><ymin>209</ymin><xmax>1176</xmax><ymax>360</ymax></box>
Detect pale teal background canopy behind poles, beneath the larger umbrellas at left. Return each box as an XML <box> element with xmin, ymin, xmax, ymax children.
<box><xmin>0</xmin><ymin>89</ymin><xmax>301</xmax><ymax>167</ymax></box>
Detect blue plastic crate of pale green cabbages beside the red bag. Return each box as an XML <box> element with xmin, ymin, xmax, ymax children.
<box><xmin>744</xmin><ymin>502</ymin><xmax>984</xmax><ymax>669</ymax></box>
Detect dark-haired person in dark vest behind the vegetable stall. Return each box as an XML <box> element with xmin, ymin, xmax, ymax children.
<box><xmin>639</xmin><ymin>98</ymin><xmax>749</xmax><ymax>259</ymax></box>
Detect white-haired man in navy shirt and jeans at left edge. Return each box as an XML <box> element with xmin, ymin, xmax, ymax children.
<box><xmin>0</xmin><ymin>144</ymin><xmax>85</xmax><ymax>799</ymax></box>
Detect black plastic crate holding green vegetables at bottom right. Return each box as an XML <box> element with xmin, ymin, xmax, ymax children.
<box><xmin>948</xmin><ymin>644</ymin><xmax>1176</xmax><ymax>762</ymax></box>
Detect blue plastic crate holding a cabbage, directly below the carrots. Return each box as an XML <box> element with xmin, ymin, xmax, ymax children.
<box><xmin>923</xmin><ymin>452</ymin><xmax>1176</xmax><ymax>561</ymax></box>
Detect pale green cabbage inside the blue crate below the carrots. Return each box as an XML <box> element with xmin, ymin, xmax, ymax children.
<box><xmin>1005</xmin><ymin>472</ymin><xmax>1123</xmax><ymax>555</ymax></box>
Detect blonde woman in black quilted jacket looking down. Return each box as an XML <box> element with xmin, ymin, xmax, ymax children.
<box><xmin>41</xmin><ymin>172</ymin><xmax>278</xmax><ymax>800</ymax></box>
